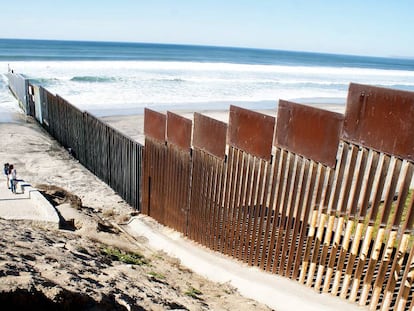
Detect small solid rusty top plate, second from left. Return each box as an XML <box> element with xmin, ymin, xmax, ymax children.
<box><xmin>167</xmin><ymin>111</ymin><xmax>192</xmax><ymax>151</ymax></box>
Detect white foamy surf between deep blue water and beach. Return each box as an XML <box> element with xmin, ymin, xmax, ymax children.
<box><xmin>0</xmin><ymin>61</ymin><xmax>414</xmax><ymax>115</ymax></box>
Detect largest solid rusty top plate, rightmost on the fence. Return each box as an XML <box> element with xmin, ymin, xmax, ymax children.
<box><xmin>343</xmin><ymin>83</ymin><xmax>414</xmax><ymax>161</ymax></box>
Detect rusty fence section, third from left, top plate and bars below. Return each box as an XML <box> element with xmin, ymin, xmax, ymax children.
<box><xmin>187</xmin><ymin>113</ymin><xmax>227</xmax><ymax>249</ymax></box>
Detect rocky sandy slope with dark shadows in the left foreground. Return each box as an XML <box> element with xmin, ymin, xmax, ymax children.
<box><xmin>0</xmin><ymin>216</ymin><xmax>266</xmax><ymax>310</ymax></box>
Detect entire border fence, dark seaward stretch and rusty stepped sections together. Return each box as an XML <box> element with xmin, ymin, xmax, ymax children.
<box><xmin>9</xmin><ymin>73</ymin><xmax>414</xmax><ymax>310</ymax></box>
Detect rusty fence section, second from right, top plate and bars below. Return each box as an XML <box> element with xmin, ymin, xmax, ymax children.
<box><xmin>274</xmin><ymin>101</ymin><xmax>343</xmax><ymax>279</ymax></box>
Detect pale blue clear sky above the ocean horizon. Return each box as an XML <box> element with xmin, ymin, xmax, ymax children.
<box><xmin>0</xmin><ymin>0</ymin><xmax>414</xmax><ymax>57</ymax></box>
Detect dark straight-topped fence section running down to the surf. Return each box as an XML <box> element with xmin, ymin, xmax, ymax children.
<box><xmin>8</xmin><ymin>72</ymin><xmax>143</xmax><ymax>210</ymax></box>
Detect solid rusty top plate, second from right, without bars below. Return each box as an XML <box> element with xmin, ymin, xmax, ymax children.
<box><xmin>275</xmin><ymin>100</ymin><xmax>343</xmax><ymax>167</ymax></box>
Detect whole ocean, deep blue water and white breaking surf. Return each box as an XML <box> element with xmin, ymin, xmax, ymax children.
<box><xmin>0</xmin><ymin>39</ymin><xmax>414</xmax><ymax>115</ymax></box>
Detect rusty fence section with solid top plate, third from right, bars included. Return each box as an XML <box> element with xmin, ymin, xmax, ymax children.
<box><xmin>223</xmin><ymin>106</ymin><xmax>275</xmax><ymax>265</ymax></box>
